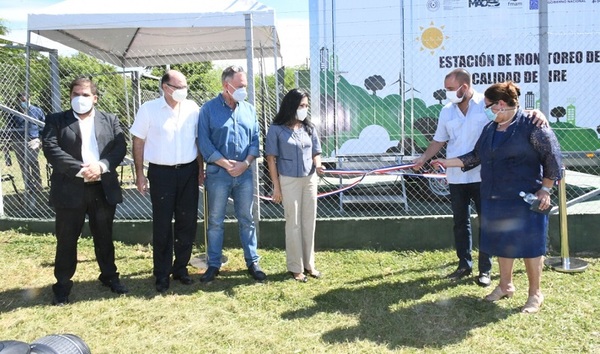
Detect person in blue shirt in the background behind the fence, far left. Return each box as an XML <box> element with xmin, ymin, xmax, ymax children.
<box><xmin>11</xmin><ymin>92</ymin><xmax>46</xmax><ymax>208</ymax></box>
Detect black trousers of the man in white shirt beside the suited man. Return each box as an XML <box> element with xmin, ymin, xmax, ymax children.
<box><xmin>148</xmin><ymin>160</ymin><xmax>199</xmax><ymax>279</ymax></box>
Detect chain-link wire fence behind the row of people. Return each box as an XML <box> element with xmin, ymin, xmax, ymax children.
<box><xmin>0</xmin><ymin>1</ymin><xmax>600</xmax><ymax>220</ymax></box>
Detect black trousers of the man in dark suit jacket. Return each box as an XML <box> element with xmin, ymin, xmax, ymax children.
<box><xmin>52</xmin><ymin>183</ymin><xmax>119</xmax><ymax>296</ymax></box>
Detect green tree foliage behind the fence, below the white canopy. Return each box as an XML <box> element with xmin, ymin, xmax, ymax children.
<box><xmin>0</xmin><ymin>35</ymin><xmax>300</xmax><ymax>132</ymax></box>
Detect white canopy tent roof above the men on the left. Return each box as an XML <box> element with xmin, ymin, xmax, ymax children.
<box><xmin>27</xmin><ymin>0</ymin><xmax>279</xmax><ymax>67</ymax></box>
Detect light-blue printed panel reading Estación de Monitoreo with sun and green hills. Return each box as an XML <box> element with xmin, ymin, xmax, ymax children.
<box><xmin>310</xmin><ymin>0</ymin><xmax>600</xmax><ymax>156</ymax></box>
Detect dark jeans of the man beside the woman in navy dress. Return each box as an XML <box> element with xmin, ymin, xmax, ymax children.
<box><xmin>450</xmin><ymin>182</ymin><xmax>492</xmax><ymax>273</ymax></box>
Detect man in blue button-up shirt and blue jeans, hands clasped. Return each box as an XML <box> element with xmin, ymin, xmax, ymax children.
<box><xmin>198</xmin><ymin>66</ymin><xmax>267</xmax><ymax>283</ymax></box>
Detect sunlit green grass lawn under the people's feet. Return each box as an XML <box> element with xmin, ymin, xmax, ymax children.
<box><xmin>0</xmin><ymin>230</ymin><xmax>600</xmax><ymax>354</ymax></box>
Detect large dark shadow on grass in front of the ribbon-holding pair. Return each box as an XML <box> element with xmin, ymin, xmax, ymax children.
<box><xmin>282</xmin><ymin>277</ymin><xmax>514</xmax><ymax>350</ymax></box>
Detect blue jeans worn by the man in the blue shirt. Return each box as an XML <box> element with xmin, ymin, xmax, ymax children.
<box><xmin>204</xmin><ymin>164</ymin><xmax>260</xmax><ymax>268</ymax></box>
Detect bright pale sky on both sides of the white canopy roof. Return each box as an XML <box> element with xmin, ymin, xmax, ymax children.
<box><xmin>0</xmin><ymin>0</ymin><xmax>309</xmax><ymax>65</ymax></box>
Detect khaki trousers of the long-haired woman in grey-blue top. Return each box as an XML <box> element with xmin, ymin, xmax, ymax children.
<box><xmin>279</xmin><ymin>173</ymin><xmax>319</xmax><ymax>273</ymax></box>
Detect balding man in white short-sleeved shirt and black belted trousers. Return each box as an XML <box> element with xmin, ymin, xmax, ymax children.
<box><xmin>130</xmin><ymin>70</ymin><xmax>204</xmax><ymax>293</ymax></box>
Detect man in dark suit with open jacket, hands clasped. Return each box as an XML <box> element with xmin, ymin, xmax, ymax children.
<box><xmin>42</xmin><ymin>78</ymin><xmax>128</xmax><ymax>306</ymax></box>
